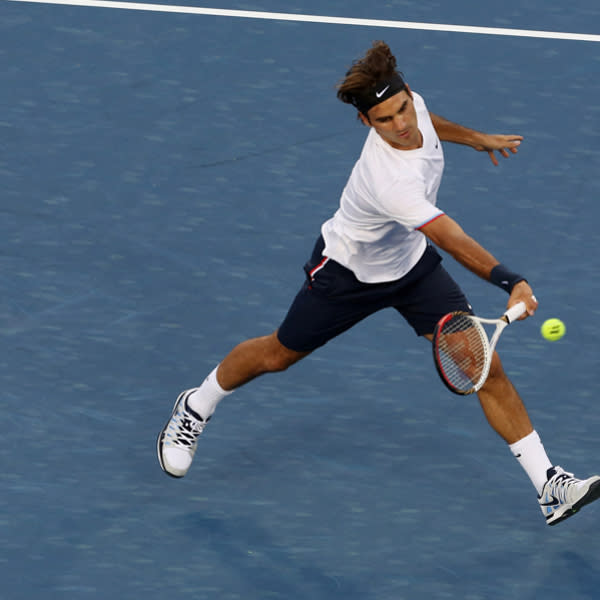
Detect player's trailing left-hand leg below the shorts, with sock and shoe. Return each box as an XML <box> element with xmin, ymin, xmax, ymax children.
<box><xmin>157</xmin><ymin>332</ymin><xmax>310</xmax><ymax>477</ymax></box>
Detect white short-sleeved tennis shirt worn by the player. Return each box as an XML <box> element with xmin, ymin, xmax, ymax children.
<box><xmin>321</xmin><ymin>92</ymin><xmax>444</xmax><ymax>283</ymax></box>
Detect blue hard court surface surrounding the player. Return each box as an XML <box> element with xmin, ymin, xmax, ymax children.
<box><xmin>0</xmin><ymin>0</ymin><xmax>600</xmax><ymax>600</ymax></box>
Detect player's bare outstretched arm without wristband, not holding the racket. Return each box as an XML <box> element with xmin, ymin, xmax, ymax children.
<box><xmin>429</xmin><ymin>112</ymin><xmax>523</xmax><ymax>166</ymax></box>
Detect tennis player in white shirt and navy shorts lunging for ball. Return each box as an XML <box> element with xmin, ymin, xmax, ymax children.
<box><xmin>157</xmin><ymin>42</ymin><xmax>600</xmax><ymax>525</ymax></box>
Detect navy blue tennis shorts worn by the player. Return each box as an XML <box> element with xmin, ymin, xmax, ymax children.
<box><xmin>277</xmin><ymin>237</ymin><xmax>471</xmax><ymax>352</ymax></box>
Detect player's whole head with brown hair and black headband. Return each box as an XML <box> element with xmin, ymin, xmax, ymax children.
<box><xmin>337</xmin><ymin>41</ymin><xmax>422</xmax><ymax>150</ymax></box>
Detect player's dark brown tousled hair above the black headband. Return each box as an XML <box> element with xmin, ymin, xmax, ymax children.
<box><xmin>337</xmin><ymin>41</ymin><xmax>397</xmax><ymax>104</ymax></box>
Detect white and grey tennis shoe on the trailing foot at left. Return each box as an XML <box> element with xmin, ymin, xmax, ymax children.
<box><xmin>156</xmin><ymin>388</ymin><xmax>210</xmax><ymax>477</ymax></box>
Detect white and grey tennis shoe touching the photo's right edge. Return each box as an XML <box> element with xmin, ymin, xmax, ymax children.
<box><xmin>538</xmin><ymin>467</ymin><xmax>600</xmax><ymax>525</ymax></box>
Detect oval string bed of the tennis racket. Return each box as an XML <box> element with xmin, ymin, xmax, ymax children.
<box><xmin>437</xmin><ymin>314</ymin><xmax>488</xmax><ymax>393</ymax></box>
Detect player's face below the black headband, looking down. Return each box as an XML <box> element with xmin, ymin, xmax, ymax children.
<box><xmin>360</xmin><ymin>90</ymin><xmax>423</xmax><ymax>150</ymax></box>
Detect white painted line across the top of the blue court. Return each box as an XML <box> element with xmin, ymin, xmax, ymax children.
<box><xmin>10</xmin><ymin>0</ymin><xmax>600</xmax><ymax>42</ymax></box>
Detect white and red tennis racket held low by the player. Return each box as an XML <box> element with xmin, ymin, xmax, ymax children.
<box><xmin>433</xmin><ymin>302</ymin><xmax>527</xmax><ymax>395</ymax></box>
